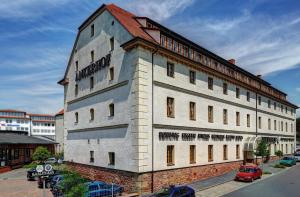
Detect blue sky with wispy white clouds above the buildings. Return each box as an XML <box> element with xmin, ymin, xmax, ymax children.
<box><xmin>0</xmin><ymin>0</ymin><xmax>300</xmax><ymax>115</ymax></box>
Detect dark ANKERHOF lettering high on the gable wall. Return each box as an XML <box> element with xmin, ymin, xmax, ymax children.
<box><xmin>75</xmin><ymin>53</ymin><xmax>111</xmax><ymax>81</ymax></box>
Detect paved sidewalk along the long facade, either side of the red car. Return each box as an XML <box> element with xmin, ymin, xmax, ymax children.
<box><xmin>189</xmin><ymin>160</ymin><xmax>283</xmax><ymax>191</ymax></box>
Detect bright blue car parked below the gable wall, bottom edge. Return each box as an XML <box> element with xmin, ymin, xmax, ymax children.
<box><xmin>85</xmin><ymin>181</ymin><xmax>124</xmax><ymax>197</ymax></box>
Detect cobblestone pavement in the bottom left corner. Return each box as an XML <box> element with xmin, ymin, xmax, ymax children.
<box><xmin>0</xmin><ymin>169</ymin><xmax>52</xmax><ymax>197</ymax></box>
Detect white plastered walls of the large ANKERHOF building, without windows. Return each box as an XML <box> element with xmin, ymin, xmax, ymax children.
<box><xmin>64</xmin><ymin>4</ymin><xmax>296</xmax><ymax>172</ymax></box>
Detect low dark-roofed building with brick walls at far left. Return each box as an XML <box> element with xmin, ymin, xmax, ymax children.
<box><xmin>0</xmin><ymin>132</ymin><xmax>55</xmax><ymax>173</ymax></box>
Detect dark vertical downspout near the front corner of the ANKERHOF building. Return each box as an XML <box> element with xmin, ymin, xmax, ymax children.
<box><xmin>151</xmin><ymin>48</ymin><xmax>158</xmax><ymax>193</ymax></box>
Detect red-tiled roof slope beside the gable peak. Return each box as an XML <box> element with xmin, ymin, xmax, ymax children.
<box><xmin>105</xmin><ymin>4</ymin><xmax>155</xmax><ymax>42</ymax></box>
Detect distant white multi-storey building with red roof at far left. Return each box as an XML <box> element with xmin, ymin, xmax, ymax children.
<box><xmin>0</xmin><ymin>109</ymin><xmax>55</xmax><ymax>140</ymax></box>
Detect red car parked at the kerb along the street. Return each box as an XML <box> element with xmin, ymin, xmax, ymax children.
<box><xmin>235</xmin><ymin>166</ymin><xmax>262</xmax><ymax>182</ymax></box>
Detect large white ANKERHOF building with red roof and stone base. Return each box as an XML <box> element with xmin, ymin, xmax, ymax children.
<box><xmin>59</xmin><ymin>4</ymin><xmax>297</xmax><ymax>193</ymax></box>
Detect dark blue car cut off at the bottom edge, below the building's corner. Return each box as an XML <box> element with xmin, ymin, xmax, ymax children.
<box><xmin>151</xmin><ymin>185</ymin><xmax>195</xmax><ymax>197</ymax></box>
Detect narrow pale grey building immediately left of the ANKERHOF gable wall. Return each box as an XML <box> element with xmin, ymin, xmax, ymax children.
<box><xmin>55</xmin><ymin>109</ymin><xmax>64</xmax><ymax>153</ymax></box>
